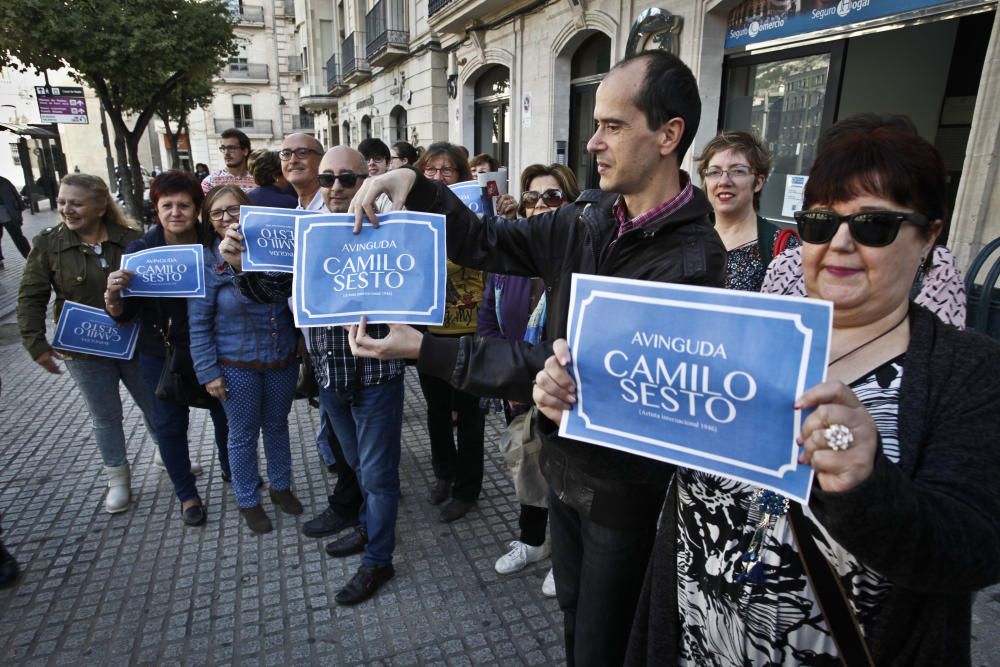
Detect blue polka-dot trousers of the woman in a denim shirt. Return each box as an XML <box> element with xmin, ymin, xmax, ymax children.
<box><xmin>220</xmin><ymin>364</ymin><xmax>299</xmax><ymax>509</ymax></box>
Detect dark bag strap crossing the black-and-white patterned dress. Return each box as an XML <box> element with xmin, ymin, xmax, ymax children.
<box><xmin>788</xmin><ymin>502</ymin><xmax>875</xmax><ymax>667</ymax></box>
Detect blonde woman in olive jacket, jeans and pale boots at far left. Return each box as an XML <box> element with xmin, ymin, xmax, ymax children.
<box><xmin>17</xmin><ymin>174</ymin><xmax>155</xmax><ymax>514</ymax></box>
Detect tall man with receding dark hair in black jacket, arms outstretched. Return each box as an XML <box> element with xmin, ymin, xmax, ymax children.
<box><xmin>352</xmin><ymin>51</ymin><xmax>726</xmax><ymax>665</ymax></box>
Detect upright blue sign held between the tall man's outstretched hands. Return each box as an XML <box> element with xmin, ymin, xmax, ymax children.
<box><xmin>292</xmin><ymin>211</ymin><xmax>447</xmax><ymax>327</ymax></box>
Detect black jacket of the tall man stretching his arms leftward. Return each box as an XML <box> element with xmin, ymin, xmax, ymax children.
<box><xmin>406</xmin><ymin>175</ymin><xmax>726</xmax><ymax>528</ymax></box>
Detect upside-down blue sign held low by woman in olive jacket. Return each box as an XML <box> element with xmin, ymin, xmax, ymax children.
<box><xmin>52</xmin><ymin>301</ymin><xmax>139</xmax><ymax>359</ymax></box>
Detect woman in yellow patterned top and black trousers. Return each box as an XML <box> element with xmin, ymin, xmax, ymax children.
<box><xmin>416</xmin><ymin>142</ymin><xmax>485</xmax><ymax>523</ymax></box>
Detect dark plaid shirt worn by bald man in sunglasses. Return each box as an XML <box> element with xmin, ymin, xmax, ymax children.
<box><xmin>236</xmin><ymin>272</ymin><xmax>405</xmax><ymax>391</ymax></box>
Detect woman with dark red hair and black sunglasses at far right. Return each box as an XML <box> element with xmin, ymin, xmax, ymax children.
<box><xmin>629</xmin><ymin>113</ymin><xmax>1000</xmax><ymax>665</ymax></box>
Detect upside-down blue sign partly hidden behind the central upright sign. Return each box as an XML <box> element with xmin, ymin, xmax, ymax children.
<box><xmin>240</xmin><ymin>206</ymin><xmax>321</xmax><ymax>273</ymax></box>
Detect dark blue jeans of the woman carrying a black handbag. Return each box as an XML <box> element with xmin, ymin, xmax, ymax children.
<box><xmin>139</xmin><ymin>354</ymin><xmax>229</xmax><ymax>503</ymax></box>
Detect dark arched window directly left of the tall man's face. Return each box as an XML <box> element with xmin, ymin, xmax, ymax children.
<box><xmin>569</xmin><ymin>33</ymin><xmax>611</xmax><ymax>190</ymax></box>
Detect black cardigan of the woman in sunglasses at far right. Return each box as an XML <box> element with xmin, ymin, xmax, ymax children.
<box><xmin>626</xmin><ymin>304</ymin><xmax>1000</xmax><ymax>667</ymax></box>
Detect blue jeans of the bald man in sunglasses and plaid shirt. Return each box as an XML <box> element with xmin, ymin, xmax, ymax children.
<box><xmin>319</xmin><ymin>376</ymin><xmax>403</xmax><ymax>567</ymax></box>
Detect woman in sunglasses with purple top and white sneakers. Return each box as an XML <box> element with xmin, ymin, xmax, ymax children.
<box><xmin>477</xmin><ymin>164</ymin><xmax>580</xmax><ymax>597</ymax></box>
